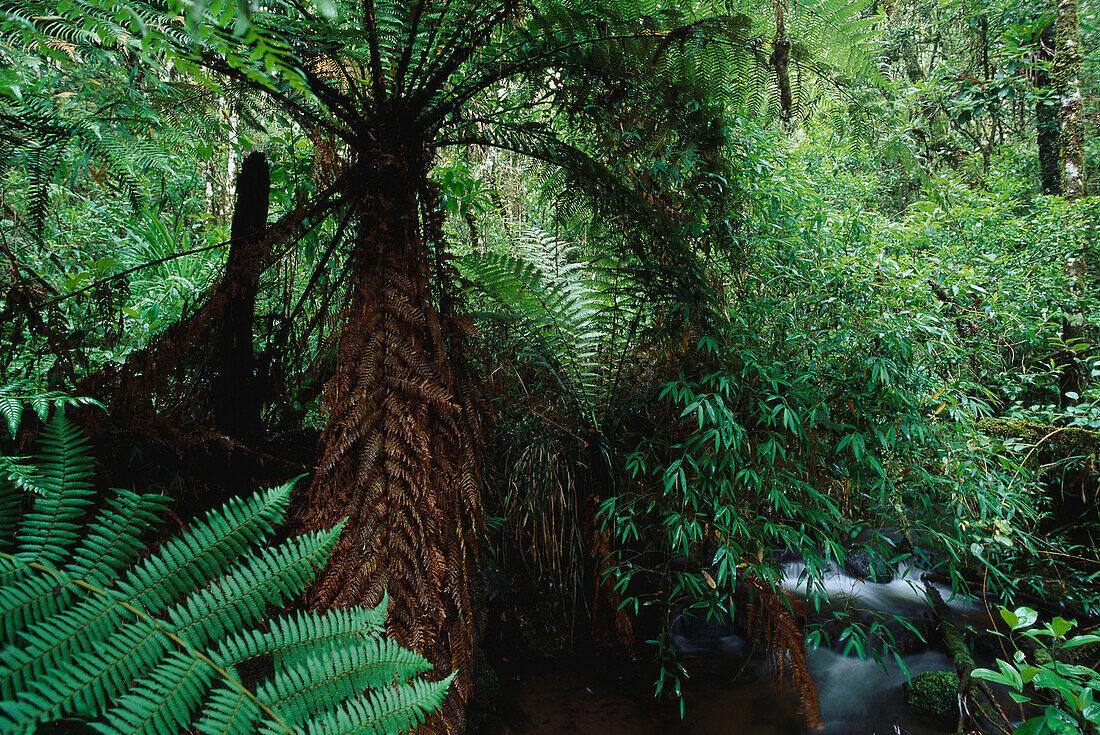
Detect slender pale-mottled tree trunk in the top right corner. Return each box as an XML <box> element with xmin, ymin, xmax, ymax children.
<box><xmin>1054</xmin><ymin>0</ymin><xmax>1085</xmax><ymax>199</ymax></box>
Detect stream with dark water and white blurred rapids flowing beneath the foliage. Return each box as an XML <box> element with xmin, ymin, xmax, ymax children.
<box><xmin>488</xmin><ymin>562</ymin><xmax>985</xmax><ymax>735</ymax></box>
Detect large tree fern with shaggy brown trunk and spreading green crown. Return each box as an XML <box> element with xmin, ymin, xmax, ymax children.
<box><xmin>0</xmin><ymin>0</ymin><xmax>884</xmax><ymax>732</ymax></box>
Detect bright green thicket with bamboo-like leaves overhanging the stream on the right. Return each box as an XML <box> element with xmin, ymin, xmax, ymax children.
<box><xmin>603</xmin><ymin>130</ymin><xmax>1098</xmax><ymax>699</ymax></box>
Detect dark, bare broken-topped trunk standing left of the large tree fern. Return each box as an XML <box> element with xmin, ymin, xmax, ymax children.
<box><xmin>211</xmin><ymin>153</ymin><xmax>272</xmax><ymax>438</ymax></box>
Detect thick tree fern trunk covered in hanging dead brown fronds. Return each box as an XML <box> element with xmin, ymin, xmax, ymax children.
<box><xmin>303</xmin><ymin>133</ymin><xmax>481</xmax><ymax>733</ymax></box>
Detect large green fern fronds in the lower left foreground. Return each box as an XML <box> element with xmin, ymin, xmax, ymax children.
<box><xmin>0</xmin><ymin>410</ymin><xmax>451</xmax><ymax>734</ymax></box>
